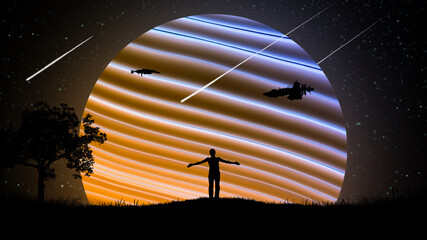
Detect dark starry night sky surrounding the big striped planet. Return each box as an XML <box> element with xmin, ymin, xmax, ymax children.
<box><xmin>0</xmin><ymin>0</ymin><xmax>427</xmax><ymax>201</ymax></box>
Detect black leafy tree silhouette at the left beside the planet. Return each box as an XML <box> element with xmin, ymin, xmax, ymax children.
<box><xmin>1</xmin><ymin>102</ymin><xmax>107</xmax><ymax>203</ymax></box>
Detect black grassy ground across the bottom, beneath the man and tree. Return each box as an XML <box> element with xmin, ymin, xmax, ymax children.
<box><xmin>1</xmin><ymin>195</ymin><xmax>426</xmax><ymax>236</ymax></box>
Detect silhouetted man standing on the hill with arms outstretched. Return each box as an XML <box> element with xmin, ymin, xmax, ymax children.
<box><xmin>187</xmin><ymin>149</ymin><xmax>240</xmax><ymax>199</ymax></box>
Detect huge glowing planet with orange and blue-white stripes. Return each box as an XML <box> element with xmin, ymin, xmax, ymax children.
<box><xmin>83</xmin><ymin>14</ymin><xmax>347</xmax><ymax>203</ymax></box>
